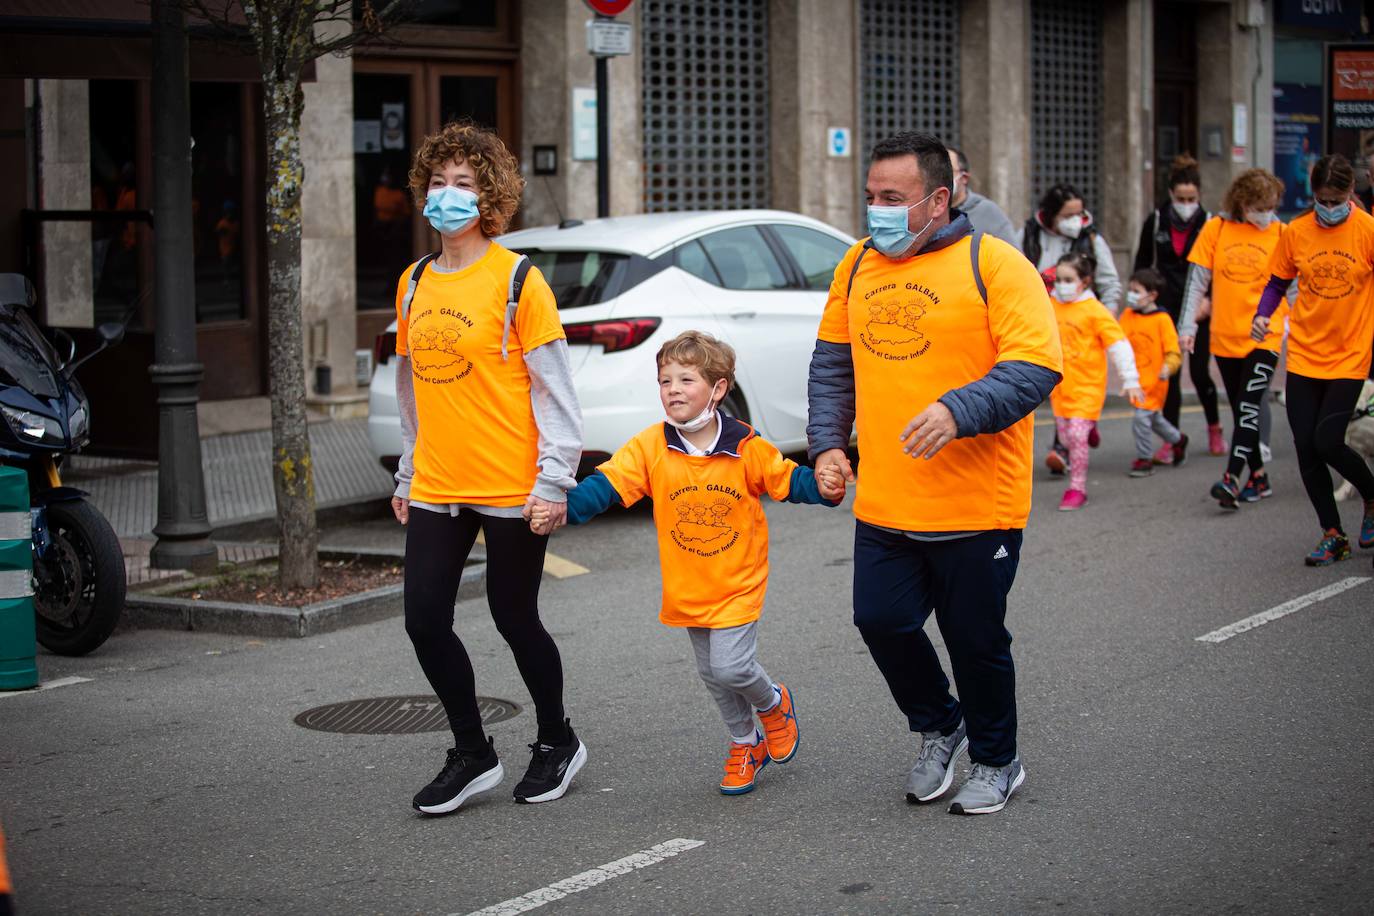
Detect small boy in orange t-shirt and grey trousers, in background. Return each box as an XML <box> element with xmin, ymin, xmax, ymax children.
<box><xmin>1121</xmin><ymin>268</ymin><xmax>1189</xmax><ymax>477</ymax></box>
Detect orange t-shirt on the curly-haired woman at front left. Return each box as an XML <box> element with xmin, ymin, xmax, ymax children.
<box><xmin>396</xmin><ymin>242</ymin><xmax>563</xmax><ymax>507</ymax></box>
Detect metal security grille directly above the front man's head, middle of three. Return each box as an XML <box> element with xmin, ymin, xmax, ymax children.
<box><xmin>860</xmin><ymin>0</ymin><xmax>959</xmax><ymax>159</ymax></box>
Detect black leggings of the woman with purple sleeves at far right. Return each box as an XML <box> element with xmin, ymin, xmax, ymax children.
<box><xmin>1287</xmin><ymin>372</ymin><xmax>1374</xmax><ymax>531</ymax></box>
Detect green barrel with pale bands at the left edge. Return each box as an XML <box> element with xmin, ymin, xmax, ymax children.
<box><xmin>0</xmin><ymin>467</ymin><xmax>38</xmax><ymax>691</ymax></box>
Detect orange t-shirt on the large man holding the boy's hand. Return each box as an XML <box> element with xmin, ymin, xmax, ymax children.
<box><xmin>819</xmin><ymin>236</ymin><xmax>1063</xmax><ymax>531</ymax></box>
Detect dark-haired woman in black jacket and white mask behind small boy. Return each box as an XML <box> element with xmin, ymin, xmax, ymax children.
<box><xmin>1134</xmin><ymin>154</ymin><xmax>1226</xmax><ymax>464</ymax></box>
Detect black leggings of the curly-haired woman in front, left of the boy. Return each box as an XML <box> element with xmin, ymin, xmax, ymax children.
<box><xmin>405</xmin><ymin>508</ymin><xmax>563</xmax><ymax>751</ymax></box>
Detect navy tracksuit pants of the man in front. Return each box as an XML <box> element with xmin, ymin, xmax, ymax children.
<box><xmin>855</xmin><ymin>522</ymin><xmax>1021</xmax><ymax>766</ymax></box>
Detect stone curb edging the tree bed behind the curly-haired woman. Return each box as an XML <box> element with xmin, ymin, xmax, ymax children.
<box><xmin>122</xmin><ymin>552</ymin><xmax>486</xmax><ymax>639</ymax></box>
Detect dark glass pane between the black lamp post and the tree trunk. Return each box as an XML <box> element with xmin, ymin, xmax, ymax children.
<box><xmin>191</xmin><ymin>82</ymin><xmax>246</xmax><ymax>324</ymax></box>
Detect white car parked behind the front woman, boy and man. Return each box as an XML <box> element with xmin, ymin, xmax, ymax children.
<box><xmin>368</xmin><ymin>210</ymin><xmax>853</xmax><ymax>472</ymax></box>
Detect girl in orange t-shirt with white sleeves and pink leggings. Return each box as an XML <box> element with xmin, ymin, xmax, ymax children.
<box><xmin>1047</xmin><ymin>251</ymin><xmax>1145</xmax><ymax>512</ymax></box>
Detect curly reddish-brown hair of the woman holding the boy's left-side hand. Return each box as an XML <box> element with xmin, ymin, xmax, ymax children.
<box><xmin>409</xmin><ymin>121</ymin><xmax>525</xmax><ymax>238</ymax></box>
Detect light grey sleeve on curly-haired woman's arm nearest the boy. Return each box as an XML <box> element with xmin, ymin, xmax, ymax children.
<box><xmin>525</xmin><ymin>339</ymin><xmax>583</xmax><ymax>503</ymax></box>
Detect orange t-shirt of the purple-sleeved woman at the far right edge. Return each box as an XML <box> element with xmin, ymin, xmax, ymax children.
<box><xmin>1252</xmin><ymin>207</ymin><xmax>1374</xmax><ymax>379</ymax></box>
